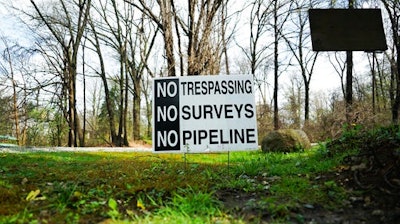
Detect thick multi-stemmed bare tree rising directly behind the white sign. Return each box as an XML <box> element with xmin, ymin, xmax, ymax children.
<box><xmin>129</xmin><ymin>0</ymin><xmax>228</xmax><ymax>76</ymax></box>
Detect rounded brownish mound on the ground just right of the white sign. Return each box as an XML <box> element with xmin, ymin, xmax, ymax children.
<box><xmin>261</xmin><ymin>129</ymin><xmax>311</xmax><ymax>152</ymax></box>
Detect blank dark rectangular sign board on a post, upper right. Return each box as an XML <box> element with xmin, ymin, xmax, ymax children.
<box><xmin>309</xmin><ymin>9</ymin><xmax>387</xmax><ymax>52</ymax></box>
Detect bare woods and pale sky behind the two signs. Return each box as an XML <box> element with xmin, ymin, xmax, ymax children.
<box><xmin>0</xmin><ymin>0</ymin><xmax>400</xmax><ymax>146</ymax></box>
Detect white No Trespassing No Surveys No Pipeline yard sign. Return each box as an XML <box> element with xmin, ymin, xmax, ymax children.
<box><xmin>153</xmin><ymin>75</ymin><xmax>258</xmax><ymax>153</ymax></box>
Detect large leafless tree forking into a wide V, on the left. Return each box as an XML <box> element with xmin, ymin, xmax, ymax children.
<box><xmin>30</xmin><ymin>0</ymin><xmax>91</xmax><ymax>146</ymax></box>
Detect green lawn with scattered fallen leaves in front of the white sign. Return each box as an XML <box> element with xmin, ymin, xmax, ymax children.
<box><xmin>0</xmin><ymin>148</ymin><xmax>354</xmax><ymax>223</ymax></box>
